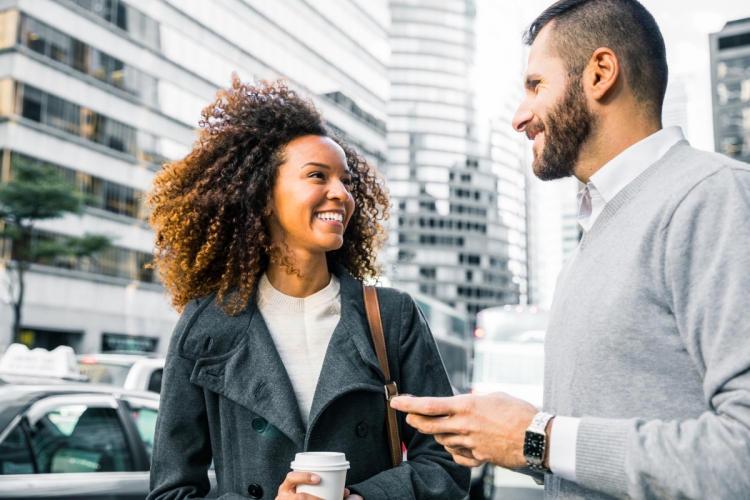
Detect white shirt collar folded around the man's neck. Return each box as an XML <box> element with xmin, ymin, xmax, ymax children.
<box><xmin>590</xmin><ymin>127</ymin><xmax>685</xmax><ymax>202</ymax></box>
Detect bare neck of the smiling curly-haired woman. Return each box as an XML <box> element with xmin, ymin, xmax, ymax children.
<box><xmin>266</xmin><ymin>254</ymin><xmax>331</xmax><ymax>298</ymax></box>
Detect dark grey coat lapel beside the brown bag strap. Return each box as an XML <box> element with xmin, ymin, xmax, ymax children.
<box><xmin>305</xmin><ymin>263</ymin><xmax>385</xmax><ymax>447</ymax></box>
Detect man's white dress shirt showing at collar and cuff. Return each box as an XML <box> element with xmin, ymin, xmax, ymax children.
<box><xmin>549</xmin><ymin>127</ymin><xmax>685</xmax><ymax>481</ymax></box>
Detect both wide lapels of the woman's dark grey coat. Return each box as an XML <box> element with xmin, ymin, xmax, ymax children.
<box><xmin>190</xmin><ymin>262</ymin><xmax>385</xmax><ymax>449</ymax></box>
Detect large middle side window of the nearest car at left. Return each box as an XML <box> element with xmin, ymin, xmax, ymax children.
<box><xmin>30</xmin><ymin>404</ymin><xmax>133</xmax><ymax>473</ymax></box>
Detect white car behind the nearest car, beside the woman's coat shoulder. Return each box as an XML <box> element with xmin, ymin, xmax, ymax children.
<box><xmin>77</xmin><ymin>353</ymin><xmax>164</xmax><ymax>393</ymax></box>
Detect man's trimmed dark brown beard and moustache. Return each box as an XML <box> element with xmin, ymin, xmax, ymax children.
<box><xmin>526</xmin><ymin>77</ymin><xmax>596</xmax><ymax>181</ymax></box>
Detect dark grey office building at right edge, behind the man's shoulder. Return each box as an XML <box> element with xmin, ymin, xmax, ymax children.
<box><xmin>709</xmin><ymin>18</ymin><xmax>750</xmax><ymax>163</ymax></box>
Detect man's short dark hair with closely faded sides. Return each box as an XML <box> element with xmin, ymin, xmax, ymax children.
<box><xmin>524</xmin><ymin>0</ymin><xmax>667</xmax><ymax>118</ymax></box>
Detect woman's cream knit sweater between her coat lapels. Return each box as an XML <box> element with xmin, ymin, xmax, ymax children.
<box><xmin>258</xmin><ymin>274</ymin><xmax>341</xmax><ymax>427</ymax></box>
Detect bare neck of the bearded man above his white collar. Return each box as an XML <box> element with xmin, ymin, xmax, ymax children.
<box><xmin>575</xmin><ymin>120</ymin><xmax>662</xmax><ymax>184</ymax></box>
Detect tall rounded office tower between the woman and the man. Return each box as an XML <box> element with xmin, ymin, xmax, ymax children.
<box><xmin>387</xmin><ymin>0</ymin><xmax>519</xmax><ymax>324</ymax></box>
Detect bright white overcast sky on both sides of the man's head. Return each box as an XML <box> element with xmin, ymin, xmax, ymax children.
<box><xmin>473</xmin><ymin>0</ymin><xmax>750</xmax><ymax>150</ymax></box>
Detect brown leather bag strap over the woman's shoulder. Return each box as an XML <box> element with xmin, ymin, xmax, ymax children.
<box><xmin>362</xmin><ymin>284</ymin><xmax>403</xmax><ymax>467</ymax></box>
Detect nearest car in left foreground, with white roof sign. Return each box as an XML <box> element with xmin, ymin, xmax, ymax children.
<box><xmin>0</xmin><ymin>348</ymin><xmax>216</xmax><ymax>500</ymax></box>
